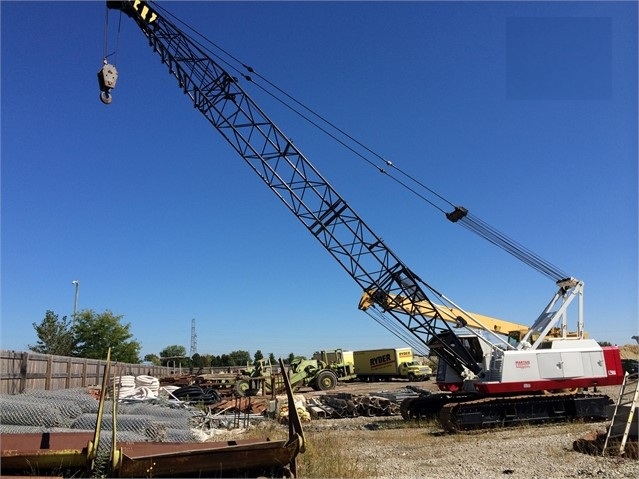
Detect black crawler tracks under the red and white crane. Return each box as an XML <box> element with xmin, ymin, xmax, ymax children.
<box><xmin>400</xmin><ymin>392</ymin><xmax>612</xmax><ymax>432</ymax></box>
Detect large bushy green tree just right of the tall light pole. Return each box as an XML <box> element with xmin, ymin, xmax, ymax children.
<box><xmin>73</xmin><ymin>309</ymin><xmax>142</xmax><ymax>363</ymax></box>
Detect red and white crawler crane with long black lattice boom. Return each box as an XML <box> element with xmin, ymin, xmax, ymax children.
<box><xmin>98</xmin><ymin>0</ymin><xmax>623</xmax><ymax>430</ymax></box>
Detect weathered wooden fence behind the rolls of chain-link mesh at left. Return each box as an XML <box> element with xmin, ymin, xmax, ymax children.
<box><xmin>0</xmin><ymin>350</ymin><xmax>170</xmax><ymax>394</ymax></box>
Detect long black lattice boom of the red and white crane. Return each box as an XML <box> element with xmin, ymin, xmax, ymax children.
<box><xmin>107</xmin><ymin>0</ymin><xmax>478</xmax><ymax>372</ymax></box>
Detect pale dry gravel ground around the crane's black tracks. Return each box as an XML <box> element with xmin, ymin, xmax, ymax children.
<box><xmin>290</xmin><ymin>381</ymin><xmax>639</xmax><ymax>479</ymax></box>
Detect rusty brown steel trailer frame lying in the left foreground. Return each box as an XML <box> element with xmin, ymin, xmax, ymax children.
<box><xmin>0</xmin><ymin>360</ymin><xmax>304</xmax><ymax>477</ymax></box>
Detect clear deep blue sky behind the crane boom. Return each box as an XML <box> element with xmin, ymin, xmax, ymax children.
<box><xmin>0</xmin><ymin>1</ymin><xmax>638</xmax><ymax>356</ymax></box>
